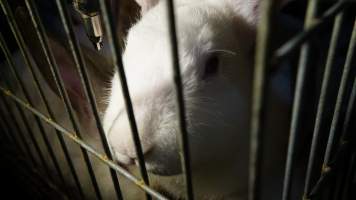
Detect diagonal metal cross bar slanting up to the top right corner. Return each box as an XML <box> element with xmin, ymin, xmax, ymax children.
<box><xmin>272</xmin><ymin>0</ymin><xmax>352</xmax><ymax>63</ymax></box>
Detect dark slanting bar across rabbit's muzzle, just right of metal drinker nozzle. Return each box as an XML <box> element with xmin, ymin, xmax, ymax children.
<box><xmin>99</xmin><ymin>0</ymin><xmax>151</xmax><ymax>195</ymax></box>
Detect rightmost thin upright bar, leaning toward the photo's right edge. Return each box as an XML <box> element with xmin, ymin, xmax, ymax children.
<box><xmin>323</xmin><ymin>20</ymin><xmax>356</xmax><ymax>167</ymax></box>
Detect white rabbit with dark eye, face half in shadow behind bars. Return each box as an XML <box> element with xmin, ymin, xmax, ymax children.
<box><xmin>103</xmin><ymin>0</ymin><xmax>298</xmax><ymax>199</ymax></box>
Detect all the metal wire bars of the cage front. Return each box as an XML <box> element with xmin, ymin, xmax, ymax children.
<box><xmin>0</xmin><ymin>0</ymin><xmax>356</xmax><ymax>200</ymax></box>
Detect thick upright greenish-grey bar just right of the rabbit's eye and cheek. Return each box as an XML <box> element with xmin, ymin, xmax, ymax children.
<box><xmin>248</xmin><ymin>0</ymin><xmax>277</xmax><ymax>200</ymax></box>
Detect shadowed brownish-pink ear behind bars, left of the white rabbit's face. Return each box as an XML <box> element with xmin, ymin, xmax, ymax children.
<box><xmin>15</xmin><ymin>8</ymin><xmax>113</xmax><ymax>118</ymax></box>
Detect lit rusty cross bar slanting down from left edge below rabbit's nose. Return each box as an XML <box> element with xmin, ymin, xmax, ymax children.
<box><xmin>0</xmin><ymin>86</ymin><xmax>168</xmax><ymax>200</ymax></box>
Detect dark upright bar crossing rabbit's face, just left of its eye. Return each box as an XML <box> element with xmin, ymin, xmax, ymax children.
<box><xmin>167</xmin><ymin>0</ymin><xmax>194</xmax><ymax>200</ymax></box>
